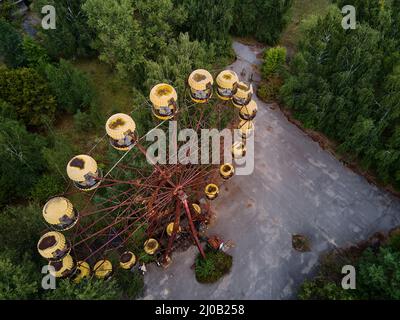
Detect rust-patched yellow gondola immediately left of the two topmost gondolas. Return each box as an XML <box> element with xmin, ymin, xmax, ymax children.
<box><xmin>150</xmin><ymin>83</ymin><xmax>178</xmax><ymax>120</ymax></box>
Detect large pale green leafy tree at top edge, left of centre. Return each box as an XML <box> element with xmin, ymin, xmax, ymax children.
<box><xmin>83</xmin><ymin>0</ymin><xmax>184</xmax><ymax>84</ymax></box>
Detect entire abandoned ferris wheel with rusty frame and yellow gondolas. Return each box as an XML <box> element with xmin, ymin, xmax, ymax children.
<box><xmin>37</xmin><ymin>69</ymin><xmax>257</xmax><ymax>282</ymax></box>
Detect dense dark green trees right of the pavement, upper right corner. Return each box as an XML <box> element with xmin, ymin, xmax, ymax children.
<box><xmin>281</xmin><ymin>0</ymin><xmax>400</xmax><ymax>189</ymax></box>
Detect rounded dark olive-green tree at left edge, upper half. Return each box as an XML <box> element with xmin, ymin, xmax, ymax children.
<box><xmin>0</xmin><ymin>68</ymin><xmax>56</xmax><ymax>127</ymax></box>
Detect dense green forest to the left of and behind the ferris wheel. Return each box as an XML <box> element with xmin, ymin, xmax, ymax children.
<box><xmin>0</xmin><ymin>0</ymin><xmax>291</xmax><ymax>299</ymax></box>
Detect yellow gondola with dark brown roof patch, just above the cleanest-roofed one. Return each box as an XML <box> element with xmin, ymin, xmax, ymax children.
<box><xmin>67</xmin><ymin>155</ymin><xmax>101</xmax><ymax>191</ymax></box>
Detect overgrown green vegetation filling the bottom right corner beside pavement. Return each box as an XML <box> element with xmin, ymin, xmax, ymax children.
<box><xmin>298</xmin><ymin>229</ymin><xmax>400</xmax><ymax>300</ymax></box>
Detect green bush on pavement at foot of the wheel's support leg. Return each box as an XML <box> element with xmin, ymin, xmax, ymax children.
<box><xmin>195</xmin><ymin>249</ymin><xmax>232</xmax><ymax>283</ymax></box>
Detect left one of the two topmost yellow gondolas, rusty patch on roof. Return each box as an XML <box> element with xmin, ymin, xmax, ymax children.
<box><xmin>188</xmin><ymin>69</ymin><xmax>214</xmax><ymax>103</ymax></box>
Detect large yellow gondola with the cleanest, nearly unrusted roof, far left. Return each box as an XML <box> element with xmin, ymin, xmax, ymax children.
<box><xmin>42</xmin><ymin>197</ymin><xmax>79</xmax><ymax>231</ymax></box>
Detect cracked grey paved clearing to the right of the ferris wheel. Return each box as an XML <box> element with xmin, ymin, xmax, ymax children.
<box><xmin>145</xmin><ymin>43</ymin><xmax>400</xmax><ymax>299</ymax></box>
